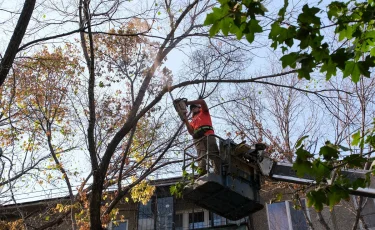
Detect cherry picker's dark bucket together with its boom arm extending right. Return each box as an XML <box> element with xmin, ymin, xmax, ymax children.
<box><xmin>183</xmin><ymin>135</ymin><xmax>375</xmax><ymax>220</ymax></box>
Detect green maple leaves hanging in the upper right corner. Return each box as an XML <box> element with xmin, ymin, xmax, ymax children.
<box><xmin>205</xmin><ymin>0</ymin><xmax>375</xmax><ymax>82</ymax></box>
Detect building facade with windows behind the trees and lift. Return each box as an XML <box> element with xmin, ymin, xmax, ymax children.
<box><xmin>0</xmin><ymin>179</ymin><xmax>375</xmax><ymax>230</ymax></box>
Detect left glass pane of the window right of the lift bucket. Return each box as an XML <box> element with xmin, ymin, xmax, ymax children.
<box><xmin>267</xmin><ymin>202</ymin><xmax>289</xmax><ymax>230</ymax></box>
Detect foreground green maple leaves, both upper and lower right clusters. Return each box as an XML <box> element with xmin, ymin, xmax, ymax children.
<box><xmin>205</xmin><ymin>0</ymin><xmax>375</xmax><ymax>221</ymax></box>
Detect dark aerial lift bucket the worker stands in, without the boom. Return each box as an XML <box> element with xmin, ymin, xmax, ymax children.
<box><xmin>183</xmin><ymin>135</ymin><xmax>263</xmax><ymax>220</ymax></box>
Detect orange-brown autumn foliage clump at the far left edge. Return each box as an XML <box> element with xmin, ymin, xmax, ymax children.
<box><xmin>0</xmin><ymin>44</ymin><xmax>83</xmax><ymax>151</ymax></box>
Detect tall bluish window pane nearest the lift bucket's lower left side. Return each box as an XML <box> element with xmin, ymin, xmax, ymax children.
<box><xmin>156</xmin><ymin>197</ymin><xmax>173</xmax><ymax>230</ymax></box>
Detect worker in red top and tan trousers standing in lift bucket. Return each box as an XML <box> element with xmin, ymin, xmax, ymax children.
<box><xmin>184</xmin><ymin>99</ymin><xmax>221</xmax><ymax>175</ymax></box>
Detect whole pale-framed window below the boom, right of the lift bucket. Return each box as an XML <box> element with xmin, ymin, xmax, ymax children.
<box><xmin>267</xmin><ymin>199</ymin><xmax>309</xmax><ymax>230</ymax></box>
